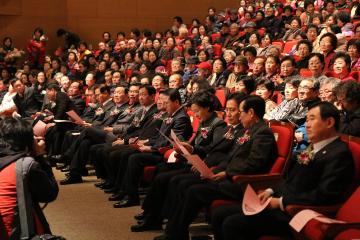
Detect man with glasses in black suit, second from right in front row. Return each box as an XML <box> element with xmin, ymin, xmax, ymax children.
<box><xmin>155</xmin><ymin>96</ymin><xmax>278</xmax><ymax>240</ymax></box>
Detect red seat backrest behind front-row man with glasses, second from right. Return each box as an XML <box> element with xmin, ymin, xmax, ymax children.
<box><xmin>269</xmin><ymin>121</ymin><xmax>294</xmax><ymax>173</ymax></box>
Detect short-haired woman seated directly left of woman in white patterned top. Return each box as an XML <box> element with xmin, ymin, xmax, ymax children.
<box><xmin>255</xmin><ymin>79</ymin><xmax>276</xmax><ymax>114</ymax></box>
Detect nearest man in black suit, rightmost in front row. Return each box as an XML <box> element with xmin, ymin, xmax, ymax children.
<box><xmin>212</xmin><ymin>102</ymin><xmax>354</xmax><ymax>239</ymax></box>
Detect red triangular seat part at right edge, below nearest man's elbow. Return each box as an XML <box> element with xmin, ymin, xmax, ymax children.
<box><xmin>336</xmin><ymin>187</ymin><xmax>360</xmax><ymax>223</ymax></box>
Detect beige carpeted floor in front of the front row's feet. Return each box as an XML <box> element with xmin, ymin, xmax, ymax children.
<box><xmin>45</xmin><ymin>171</ymin><xmax>161</xmax><ymax>240</ymax></box>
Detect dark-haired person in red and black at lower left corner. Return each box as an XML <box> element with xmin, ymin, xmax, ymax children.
<box><xmin>0</xmin><ymin>118</ymin><xmax>59</xmax><ymax>240</ymax></box>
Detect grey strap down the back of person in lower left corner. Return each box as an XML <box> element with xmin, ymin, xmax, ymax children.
<box><xmin>16</xmin><ymin>158</ymin><xmax>65</xmax><ymax>240</ymax></box>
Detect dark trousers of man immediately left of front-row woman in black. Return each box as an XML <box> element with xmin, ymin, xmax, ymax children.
<box><xmin>120</xmin><ymin>152</ymin><xmax>163</xmax><ymax>199</ymax></box>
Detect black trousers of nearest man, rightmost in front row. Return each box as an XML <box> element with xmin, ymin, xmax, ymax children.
<box><xmin>211</xmin><ymin>204</ymin><xmax>292</xmax><ymax>240</ymax></box>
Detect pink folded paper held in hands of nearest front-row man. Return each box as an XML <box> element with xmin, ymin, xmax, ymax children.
<box><xmin>242</xmin><ymin>184</ymin><xmax>271</xmax><ymax>215</ymax></box>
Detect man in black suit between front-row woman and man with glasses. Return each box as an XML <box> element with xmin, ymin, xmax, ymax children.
<box><xmin>131</xmin><ymin>93</ymin><xmax>244</xmax><ymax>232</ymax></box>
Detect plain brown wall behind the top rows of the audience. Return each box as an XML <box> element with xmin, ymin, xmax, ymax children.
<box><xmin>0</xmin><ymin>0</ymin><xmax>238</xmax><ymax>55</ymax></box>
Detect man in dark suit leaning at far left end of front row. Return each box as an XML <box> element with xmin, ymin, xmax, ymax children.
<box><xmin>11</xmin><ymin>79</ymin><xmax>41</xmax><ymax>119</ymax></box>
